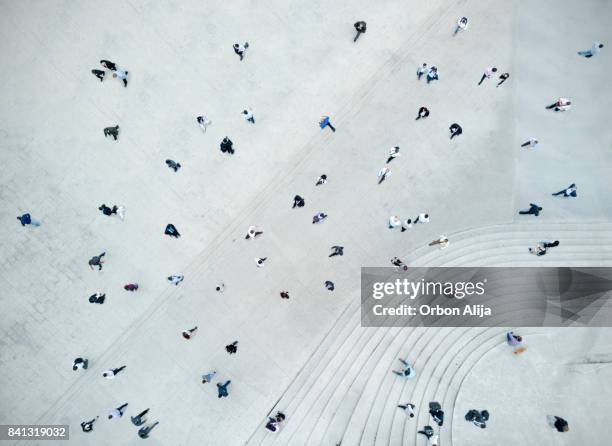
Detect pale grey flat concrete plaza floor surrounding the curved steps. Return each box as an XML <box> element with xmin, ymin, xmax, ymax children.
<box><xmin>0</xmin><ymin>0</ymin><xmax>612</xmax><ymax>445</ymax></box>
